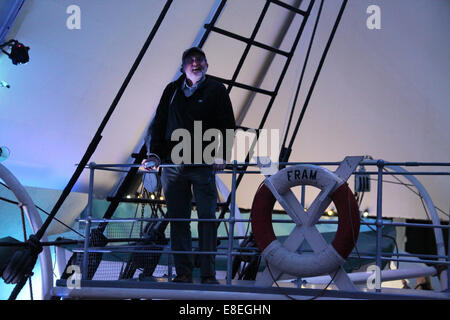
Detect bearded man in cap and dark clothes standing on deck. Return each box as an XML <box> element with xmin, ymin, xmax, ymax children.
<box><xmin>142</xmin><ymin>47</ymin><xmax>235</xmax><ymax>284</ymax></box>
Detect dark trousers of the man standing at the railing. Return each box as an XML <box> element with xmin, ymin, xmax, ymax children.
<box><xmin>161</xmin><ymin>166</ymin><xmax>217</xmax><ymax>277</ymax></box>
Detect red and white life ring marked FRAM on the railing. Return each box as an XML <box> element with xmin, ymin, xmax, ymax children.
<box><xmin>251</xmin><ymin>165</ymin><xmax>360</xmax><ymax>277</ymax></box>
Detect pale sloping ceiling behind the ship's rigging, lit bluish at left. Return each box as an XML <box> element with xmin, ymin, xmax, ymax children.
<box><xmin>0</xmin><ymin>0</ymin><xmax>450</xmax><ymax>222</ymax></box>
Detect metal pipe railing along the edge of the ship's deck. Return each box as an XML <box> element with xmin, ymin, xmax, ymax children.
<box><xmin>71</xmin><ymin>160</ymin><xmax>450</xmax><ymax>291</ymax></box>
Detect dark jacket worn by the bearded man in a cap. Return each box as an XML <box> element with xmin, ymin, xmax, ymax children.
<box><xmin>149</xmin><ymin>75</ymin><xmax>236</xmax><ymax>163</ymax></box>
